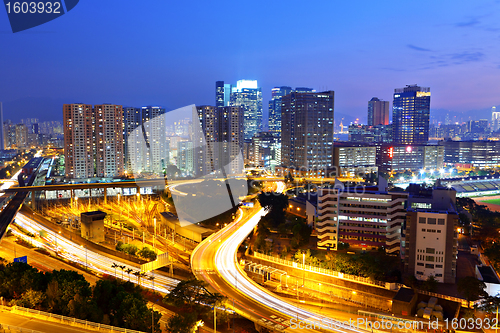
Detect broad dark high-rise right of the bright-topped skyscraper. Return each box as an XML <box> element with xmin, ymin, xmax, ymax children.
<box><xmin>281</xmin><ymin>91</ymin><xmax>334</xmax><ymax>170</ymax></box>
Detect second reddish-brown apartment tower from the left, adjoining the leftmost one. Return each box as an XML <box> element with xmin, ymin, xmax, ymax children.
<box><xmin>94</xmin><ymin>104</ymin><xmax>124</xmax><ymax>178</ymax></box>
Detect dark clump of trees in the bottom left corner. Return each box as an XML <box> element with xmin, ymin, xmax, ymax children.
<box><xmin>0</xmin><ymin>262</ymin><xmax>161</xmax><ymax>332</ymax></box>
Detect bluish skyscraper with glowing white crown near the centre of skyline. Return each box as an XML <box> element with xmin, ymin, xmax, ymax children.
<box><xmin>230</xmin><ymin>80</ymin><xmax>262</xmax><ymax>141</ymax></box>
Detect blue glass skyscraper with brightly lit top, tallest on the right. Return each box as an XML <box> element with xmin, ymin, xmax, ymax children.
<box><xmin>392</xmin><ymin>85</ymin><xmax>431</xmax><ymax>144</ymax></box>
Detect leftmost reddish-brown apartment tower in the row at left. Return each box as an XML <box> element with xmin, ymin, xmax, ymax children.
<box><xmin>63</xmin><ymin>104</ymin><xmax>95</xmax><ymax>178</ymax></box>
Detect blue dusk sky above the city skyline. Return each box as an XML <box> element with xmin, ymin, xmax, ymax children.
<box><xmin>0</xmin><ymin>0</ymin><xmax>500</xmax><ymax>122</ymax></box>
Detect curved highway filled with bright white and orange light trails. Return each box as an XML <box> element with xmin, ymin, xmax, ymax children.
<box><xmin>191</xmin><ymin>183</ymin><xmax>366</xmax><ymax>333</ymax></box>
